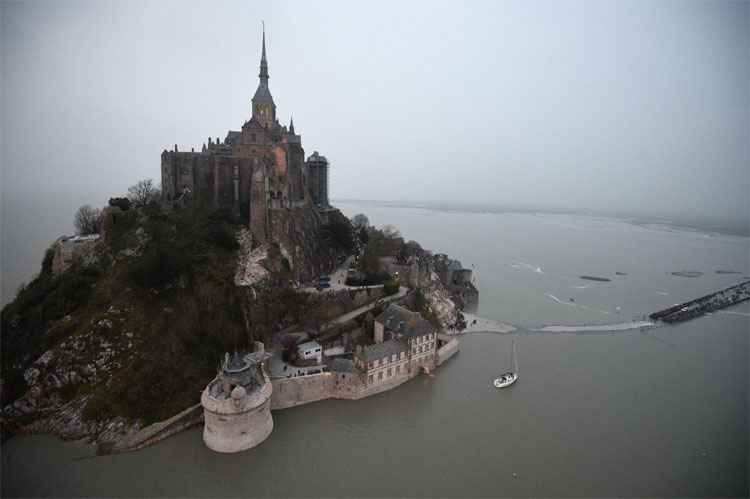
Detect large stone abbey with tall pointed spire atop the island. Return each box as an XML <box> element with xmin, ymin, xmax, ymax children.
<box><xmin>161</xmin><ymin>27</ymin><xmax>330</xmax><ymax>241</ymax></box>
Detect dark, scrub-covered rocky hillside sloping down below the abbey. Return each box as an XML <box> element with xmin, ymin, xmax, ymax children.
<box><xmin>1</xmin><ymin>201</ymin><xmax>348</xmax><ymax>440</ymax></box>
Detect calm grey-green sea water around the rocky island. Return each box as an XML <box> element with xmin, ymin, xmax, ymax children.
<box><xmin>2</xmin><ymin>203</ymin><xmax>750</xmax><ymax>497</ymax></box>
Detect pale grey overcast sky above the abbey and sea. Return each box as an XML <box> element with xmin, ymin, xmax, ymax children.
<box><xmin>0</xmin><ymin>0</ymin><xmax>750</xmax><ymax>224</ymax></box>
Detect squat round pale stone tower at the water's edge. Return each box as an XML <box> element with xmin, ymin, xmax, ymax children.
<box><xmin>201</xmin><ymin>341</ymin><xmax>273</xmax><ymax>452</ymax></box>
